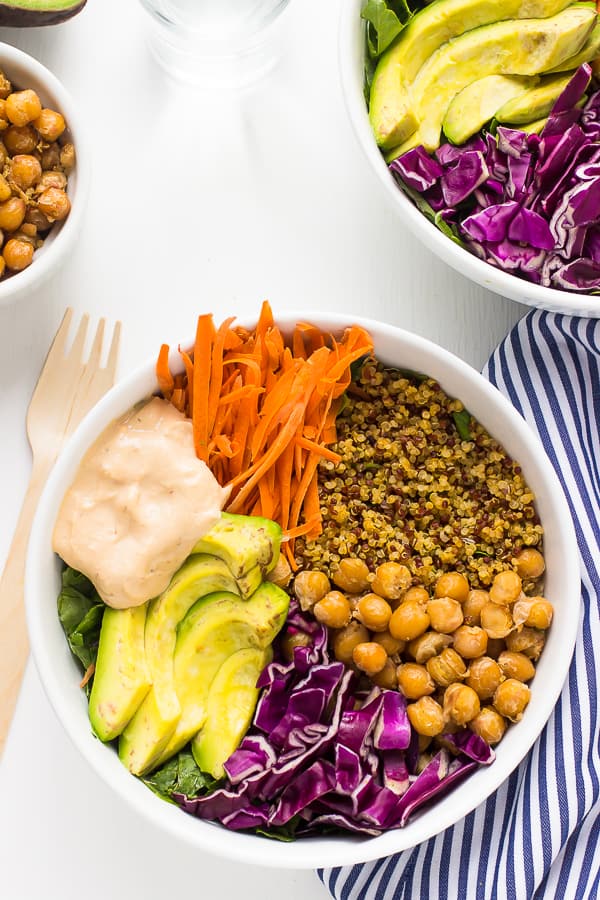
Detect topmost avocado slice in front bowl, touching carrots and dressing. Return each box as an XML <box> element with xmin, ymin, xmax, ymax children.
<box><xmin>194</xmin><ymin>513</ymin><xmax>281</xmax><ymax>597</ymax></box>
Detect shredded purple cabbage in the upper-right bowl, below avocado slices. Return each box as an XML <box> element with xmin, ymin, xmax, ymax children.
<box><xmin>390</xmin><ymin>63</ymin><xmax>600</xmax><ymax>291</ymax></box>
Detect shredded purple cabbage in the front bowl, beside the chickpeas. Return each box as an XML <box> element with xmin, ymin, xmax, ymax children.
<box><xmin>174</xmin><ymin>603</ymin><xmax>494</xmax><ymax>835</ymax></box>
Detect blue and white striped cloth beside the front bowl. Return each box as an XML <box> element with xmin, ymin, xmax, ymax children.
<box><xmin>319</xmin><ymin>310</ymin><xmax>600</xmax><ymax>900</ymax></box>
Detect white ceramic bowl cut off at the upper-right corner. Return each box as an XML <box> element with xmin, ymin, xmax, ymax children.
<box><xmin>339</xmin><ymin>0</ymin><xmax>600</xmax><ymax>317</ymax></box>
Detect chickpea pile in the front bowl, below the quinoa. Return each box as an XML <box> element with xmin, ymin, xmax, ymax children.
<box><xmin>294</xmin><ymin>548</ymin><xmax>553</xmax><ymax>746</ymax></box>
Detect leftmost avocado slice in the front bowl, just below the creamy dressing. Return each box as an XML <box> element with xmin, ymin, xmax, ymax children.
<box><xmin>89</xmin><ymin>603</ymin><xmax>151</xmax><ymax>741</ymax></box>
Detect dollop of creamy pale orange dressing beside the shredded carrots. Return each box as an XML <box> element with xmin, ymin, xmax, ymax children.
<box><xmin>53</xmin><ymin>397</ymin><xmax>228</xmax><ymax>609</ymax></box>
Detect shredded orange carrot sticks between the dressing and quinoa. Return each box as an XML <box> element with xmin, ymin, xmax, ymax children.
<box><xmin>156</xmin><ymin>301</ymin><xmax>373</xmax><ymax>556</ymax></box>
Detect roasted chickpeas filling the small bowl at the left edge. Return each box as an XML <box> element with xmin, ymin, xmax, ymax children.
<box><xmin>0</xmin><ymin>72</ymin><xmax>75</xmax><ymax>278</ymax></box>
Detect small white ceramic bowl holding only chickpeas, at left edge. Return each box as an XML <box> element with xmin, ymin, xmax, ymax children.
<box><xmin>0</xmin><ymin>43</ymin><xmax>90</xmax><ymax>305</ymax></box>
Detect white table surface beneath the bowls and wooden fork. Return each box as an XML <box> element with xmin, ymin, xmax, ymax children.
<box><xmin>0</xmin><ymin>0</ymin><xmax>525</xmax><ymax>900</ymax></box>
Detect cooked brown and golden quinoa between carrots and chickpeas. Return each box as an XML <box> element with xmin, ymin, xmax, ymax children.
<box><xmin>296</xmin><ymin>360</ymin><xmax>542</xmax><ymax>587</ymax></box>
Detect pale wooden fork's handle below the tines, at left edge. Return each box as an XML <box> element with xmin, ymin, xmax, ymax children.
<box><xmin>0</xmin><ymin>458</ymin><xmax>54</xmax><ymax>759</ymax></box>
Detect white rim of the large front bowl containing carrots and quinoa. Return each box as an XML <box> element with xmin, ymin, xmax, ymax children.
<box><xmin>25</xmin><ymin>311</ymin><xmax>581</xmax><ymax>868</ymax></box>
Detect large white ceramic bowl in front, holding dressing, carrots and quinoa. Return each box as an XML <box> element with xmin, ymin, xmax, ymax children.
<box><xmin>26</xmin><ymin>314</ymin><xmax>580</xmax><ymax>868</ymax></box>
